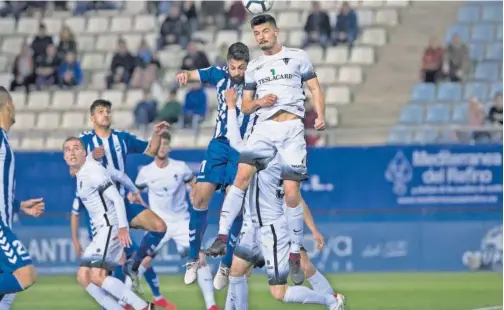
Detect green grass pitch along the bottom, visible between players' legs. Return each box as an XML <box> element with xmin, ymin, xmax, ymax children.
<box><xmin>12</xmin><ymin>273</ymin><xmax>502</xmax><ymax>310</ymax></box>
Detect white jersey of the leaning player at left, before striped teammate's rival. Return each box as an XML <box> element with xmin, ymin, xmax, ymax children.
<box><xmin>76</xmin><ymin>156</ymin><xmax>127</xmax><ymax>230</ymax></box>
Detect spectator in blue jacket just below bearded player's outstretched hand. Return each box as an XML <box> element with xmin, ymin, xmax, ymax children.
<box><xmin>183</xmin><ymin>83</ymin><xmax>207</xmax><ymax>131</ymax></box>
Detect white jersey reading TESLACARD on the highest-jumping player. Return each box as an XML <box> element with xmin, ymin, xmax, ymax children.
<box><xmin>244</xmin><ymin>46</ymin><xmax>317</xmax><ymax>122</ymax></box>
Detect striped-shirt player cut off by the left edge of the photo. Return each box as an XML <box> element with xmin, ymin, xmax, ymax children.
<box><xmin>0</xmin><ymin>86</ymin><xmax>45</xmax><ymax>309</ymax></box>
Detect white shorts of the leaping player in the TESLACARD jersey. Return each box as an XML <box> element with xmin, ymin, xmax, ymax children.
<box><xmin>240</xmin><ymin>119</ymin><xmax>308</xmax><ymax>181</ymax></box>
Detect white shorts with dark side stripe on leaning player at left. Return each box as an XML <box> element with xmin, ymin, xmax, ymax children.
<box><xmin>81</xmin><ymin>226</ymin><xmax>124</xmax><ymax>270</ymax></box>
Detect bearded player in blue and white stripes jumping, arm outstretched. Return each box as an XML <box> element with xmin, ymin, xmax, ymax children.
<box><xmin>176</xmin><ymin>42</ymin><xmax>254</xmax><ymax>287</ymax></box>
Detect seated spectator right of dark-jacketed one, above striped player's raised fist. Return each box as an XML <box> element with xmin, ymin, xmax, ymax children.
<box><xmin>130</xmin><ymin>40</ymin><xmax>161</xmax><ymax>89</ymax></box>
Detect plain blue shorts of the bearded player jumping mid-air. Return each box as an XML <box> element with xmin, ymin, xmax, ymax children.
<box><xmin>196</xmin><ymin>137</ymin><xmax>240</xmax><ymax>190</ymax></box>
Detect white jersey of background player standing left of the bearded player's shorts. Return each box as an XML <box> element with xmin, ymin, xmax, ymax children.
<box><xmin>135</xmin><ymin>158</ymin><xmax>193</xmax><ymax>222</ymax></box>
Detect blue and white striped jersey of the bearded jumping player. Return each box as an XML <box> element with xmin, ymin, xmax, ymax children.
<box><xmin>198</xmin><ymin>66</ymin><xmax>254</xmax><ymax>138</ymax></box>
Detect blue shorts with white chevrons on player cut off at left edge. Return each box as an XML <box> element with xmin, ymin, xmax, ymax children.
<box><xmin>0</xmin><ymin>224</ymin><xmax>33</xmax><ymax>273</ymax></box>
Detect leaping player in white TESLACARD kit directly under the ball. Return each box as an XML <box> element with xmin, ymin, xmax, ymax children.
<box><xmin>209</xmin><ymin>14</ymin><xmax>325</xmax><ymax>285</ymax></box>
